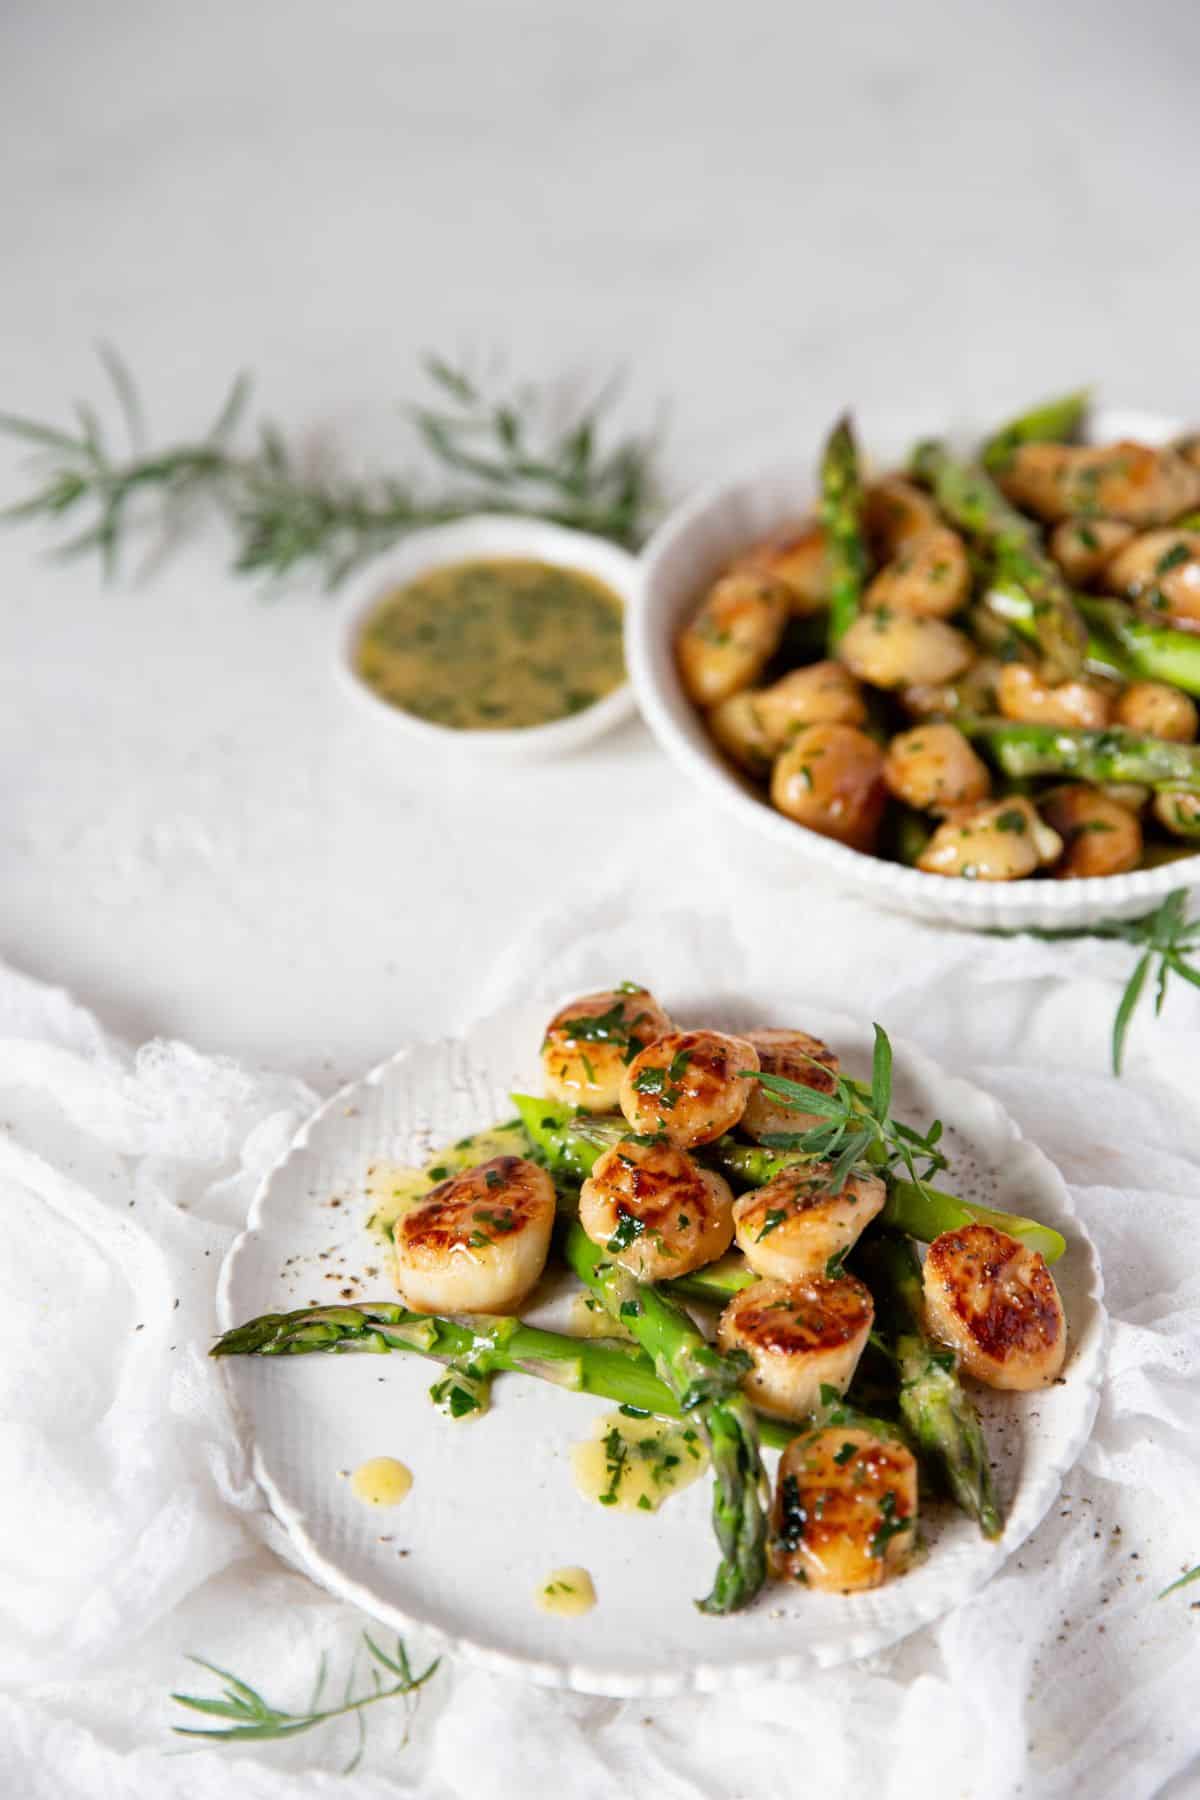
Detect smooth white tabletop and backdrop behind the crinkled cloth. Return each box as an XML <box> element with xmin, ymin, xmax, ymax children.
<box><xmin>0</xmin><ymin>0</ymin><xmax>1200</xmax><ymax>1087</ymax></box>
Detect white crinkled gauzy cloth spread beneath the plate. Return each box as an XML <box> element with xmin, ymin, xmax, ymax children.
<box><xmin>0</xmin><ymin>889</ymin><xmax>1200</xmax><ymax>1800</ymax></box>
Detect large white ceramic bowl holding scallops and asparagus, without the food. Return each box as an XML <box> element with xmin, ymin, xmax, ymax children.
<box><xmin>626</xmin><ymin>410</ymin><xmax>1200</xmax><ymax>929</ymax></box>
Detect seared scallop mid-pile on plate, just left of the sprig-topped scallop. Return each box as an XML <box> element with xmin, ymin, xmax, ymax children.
<box><xmin>579</xmin><ymin>1138</ymin><xmax>734</xmax><ymax>1282</ymax></box>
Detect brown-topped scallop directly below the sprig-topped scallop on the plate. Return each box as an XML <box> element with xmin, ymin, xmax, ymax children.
<box><xmin>716</xmin><ymin>1274</ymin><xmax>874</xmax><ymax>1420</ymax></box>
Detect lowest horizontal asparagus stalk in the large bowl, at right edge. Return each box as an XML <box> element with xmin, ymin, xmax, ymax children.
<box><xmin>972</xmin><ymin>720</ymin><xmax>1200</xmax><ymax>794</ymax></box>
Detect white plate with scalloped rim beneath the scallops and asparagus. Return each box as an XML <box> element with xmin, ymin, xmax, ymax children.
<box><xmin>218</xmin><ymin>1001</ymin><xmax>1105</xmax><ymax>1696</ymax></box>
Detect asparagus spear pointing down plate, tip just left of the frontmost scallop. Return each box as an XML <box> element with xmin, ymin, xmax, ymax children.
<box><xmin>567</xmin><ymin>1224</ymin><xmax>766</xmax><ymax>1613</ymax></box>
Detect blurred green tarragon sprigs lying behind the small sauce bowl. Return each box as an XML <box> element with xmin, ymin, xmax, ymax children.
<box><xmin>0</xmin><ymin>349</ymin><xmax>653</xmax><ymax>587</ymax></box>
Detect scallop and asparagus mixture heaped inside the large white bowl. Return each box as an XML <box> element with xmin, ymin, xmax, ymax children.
<box><xmin>676</xmin><ymin>396</ymin><xmax>1200</xmax><ymax>882</ymax></box>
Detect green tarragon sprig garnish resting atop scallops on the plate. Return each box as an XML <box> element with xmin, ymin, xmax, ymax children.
<box><xmin>743</xmin><ymin>1024</ymin><xmax>946</xmax><ymax>1193</ymax></box>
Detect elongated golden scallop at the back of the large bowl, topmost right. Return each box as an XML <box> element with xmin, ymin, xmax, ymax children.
<box><xmin>999</xmin><ymin>439</ymin><xmax>1200</xmax><ymax>527</ymax></box>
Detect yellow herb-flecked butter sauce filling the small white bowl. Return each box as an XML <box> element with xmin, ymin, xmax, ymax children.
<box><xmin>354</xmin><ymin>558</ymin><xmax>624</xmax><ymax>731</ymax></box>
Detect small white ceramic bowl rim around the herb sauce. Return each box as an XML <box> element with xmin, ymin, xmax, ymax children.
<box><xmin>336</xmin><ymin>513</ymin><xmax>639</xmax><ymax>758</ymax></box>
